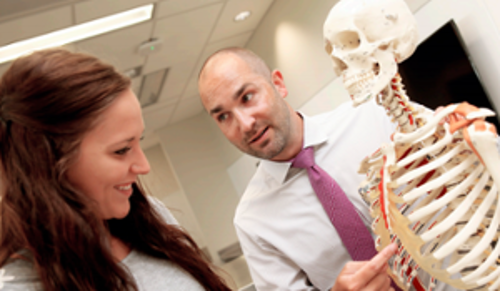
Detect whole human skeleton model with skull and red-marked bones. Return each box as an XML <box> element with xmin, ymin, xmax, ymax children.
<box><xmin>324</xmin><ymin>0</ymin><xmax>500</xmax><ymax>290</ymax></box>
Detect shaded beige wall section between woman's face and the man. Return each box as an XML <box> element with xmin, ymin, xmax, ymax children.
<box><xmin>157</xmin><ymin>113</ymin><xmax>241</xmax><ymax>263</ymax></box>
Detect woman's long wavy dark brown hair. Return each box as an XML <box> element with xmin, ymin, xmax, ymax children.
<box><xmin>0</xmin><ymin>49</ymin><xmax>229</xmax><ymax>290</ymax></box>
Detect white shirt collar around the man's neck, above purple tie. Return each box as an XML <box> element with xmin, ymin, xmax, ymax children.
<box><xmin>261</xmin><ymin>112</ymin><xmax>328</xmax><ymax>184</ymax></box>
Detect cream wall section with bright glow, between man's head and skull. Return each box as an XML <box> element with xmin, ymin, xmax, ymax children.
<box><xmin>246</xmin><ymin>0</ymin><xmax>337</xmax><ymax>108</ymax></box>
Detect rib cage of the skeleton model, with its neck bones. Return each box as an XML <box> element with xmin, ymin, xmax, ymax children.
<box><xmin>360</xmin><ymin>76</ymin><xmax>500</xmax><ymax>290</ymax></box>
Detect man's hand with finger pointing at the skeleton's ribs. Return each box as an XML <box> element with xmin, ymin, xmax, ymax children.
<box><xmin>330</xmin><ymin>244</ymin><xmax>397</xmax><ymax>291</ymax></box>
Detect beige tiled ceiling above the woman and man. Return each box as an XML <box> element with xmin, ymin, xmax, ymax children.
<box><xmin>0</xmin><ymin>0</ymin><xmax>273</xmax><ymax>139</ymax></box>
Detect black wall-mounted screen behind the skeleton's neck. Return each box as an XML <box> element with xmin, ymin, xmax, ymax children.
<box><xmin>399</xmin><ymin>20</ymin><xmax>500</xmax><ymax>130</ymax></box>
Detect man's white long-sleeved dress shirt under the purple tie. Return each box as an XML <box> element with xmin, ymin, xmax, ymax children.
<box><xmin>234</xmin><ymin>101</ymin><xmax>395</xmax><ymax>290</ymax></box>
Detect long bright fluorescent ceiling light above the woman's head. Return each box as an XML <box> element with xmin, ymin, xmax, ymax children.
<box><xmin>0</xmin><ymin>4</ymin><xmax>154</xmax><ymax>64</ymax></box>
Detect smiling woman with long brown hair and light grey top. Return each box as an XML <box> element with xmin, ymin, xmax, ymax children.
<box><xmin>0</xmin><ymin>49</ymin><xmax>229</xmax><ymax>290</ymax></box>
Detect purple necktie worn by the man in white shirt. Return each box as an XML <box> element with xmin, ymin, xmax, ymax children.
<box><xmin>292</xmin><ymin>147</ymin><xmax>377</xmax><ymax>261</ymax></box>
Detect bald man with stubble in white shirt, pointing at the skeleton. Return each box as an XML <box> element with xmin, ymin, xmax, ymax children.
<box><xmin>198</xmin><ymin>48</ymin><xmax>395</xmax><ymax>290</ymax></box>
